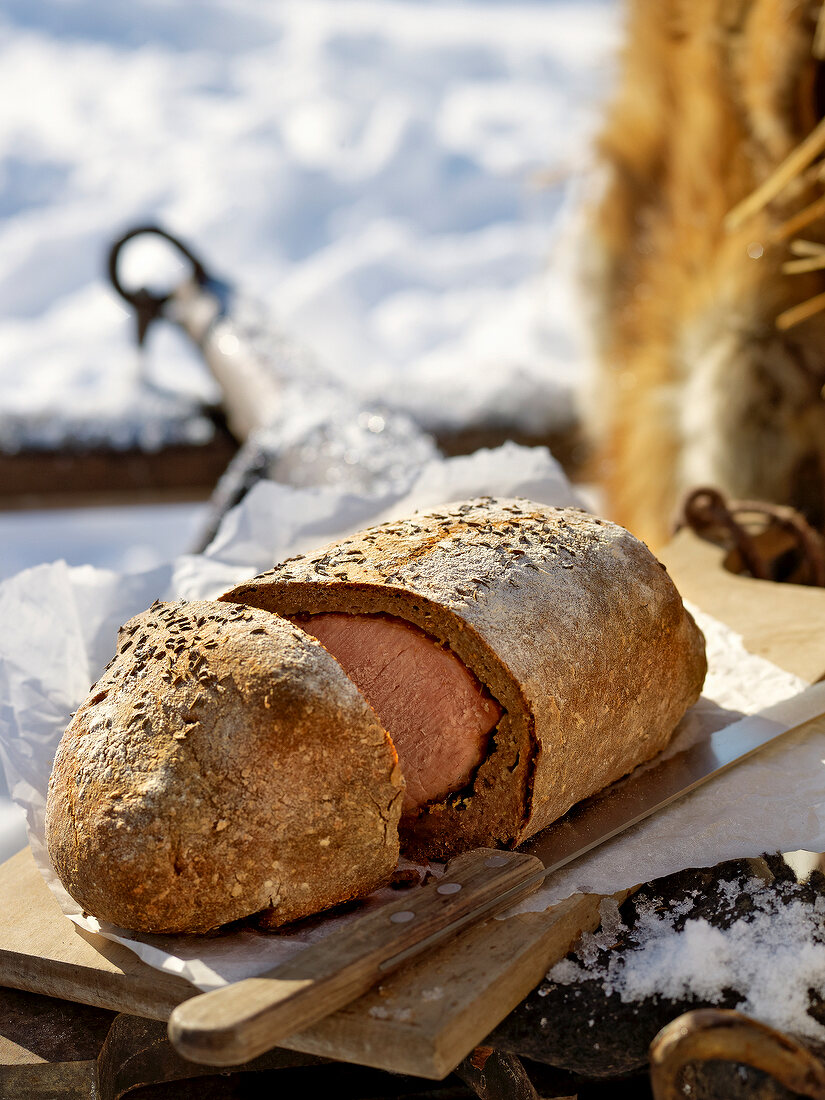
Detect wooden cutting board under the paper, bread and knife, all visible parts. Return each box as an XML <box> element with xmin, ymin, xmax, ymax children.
<box><xmin>0</xmin><ymin>532</ymin><xmax>825</xmax><ymax>1079</ymax></box>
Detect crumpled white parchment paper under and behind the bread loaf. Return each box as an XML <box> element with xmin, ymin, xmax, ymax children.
<box><xmin>0</xmin><ymin>444</ymin><xmax>825</xmax><ymax>989</ymax></box>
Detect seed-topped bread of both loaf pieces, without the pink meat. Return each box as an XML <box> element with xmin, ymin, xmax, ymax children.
<box><xmin>46</xmin><ymin>498</ymin><xmax>705</xmax><ymax>932</ymax></box>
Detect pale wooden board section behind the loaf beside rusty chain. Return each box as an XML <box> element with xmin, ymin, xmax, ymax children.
<box><xmin>658</xmin><ymin>528</ymin><xmax>825</xmax><ymax>683</ymax></box>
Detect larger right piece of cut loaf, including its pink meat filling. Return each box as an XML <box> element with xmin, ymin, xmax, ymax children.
<box><xmin>221</xmin><ymin>497</ymin><xmax>706</xmax><ymax>858</ymax></box>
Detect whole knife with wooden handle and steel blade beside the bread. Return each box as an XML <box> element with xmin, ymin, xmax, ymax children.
<box><xmin>169</xmin><ymin>682</ymin><xmax>825</xmax><ymax>1066</ymax></box>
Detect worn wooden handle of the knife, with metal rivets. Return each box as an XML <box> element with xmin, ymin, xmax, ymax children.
<box><xmin>169</xmin><ymin>848</ymin><xmax>545</xmax><ymax>1066</ymax></box>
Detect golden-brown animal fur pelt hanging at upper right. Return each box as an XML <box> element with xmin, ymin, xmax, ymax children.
<box><xmin>583</xmin><ymin>0</ymin><xmax>825</xmax><ymax>546</ymax></box>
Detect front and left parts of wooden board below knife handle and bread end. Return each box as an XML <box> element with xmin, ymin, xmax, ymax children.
<box><xmin>0</xmin><ymin>849</ymin><xmax>616</xmax><ymax>1079</ymax></box>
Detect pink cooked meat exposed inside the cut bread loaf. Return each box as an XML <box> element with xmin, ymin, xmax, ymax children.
<box><xmin>295</xmin><ymin>613</ymin><xmax>504</xmax><ymax>814</ymax></box>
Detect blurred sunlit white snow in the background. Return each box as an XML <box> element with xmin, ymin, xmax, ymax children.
<box><xmin>0</xmin><ymin>0</ymin><xmax>619</xmax><ymax>853</ymax></box>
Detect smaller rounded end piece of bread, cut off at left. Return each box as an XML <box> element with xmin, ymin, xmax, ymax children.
<box><xmin>46</xmin><ymin>602</ymin><xmax>403</xmax><ymax>932</ymax></box>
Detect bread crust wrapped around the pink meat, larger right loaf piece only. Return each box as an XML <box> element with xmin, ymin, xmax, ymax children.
<box><xmin>221</xmin><ymin>497</ymin><xmax>706</xmax><ymax>858</ymax></box>
